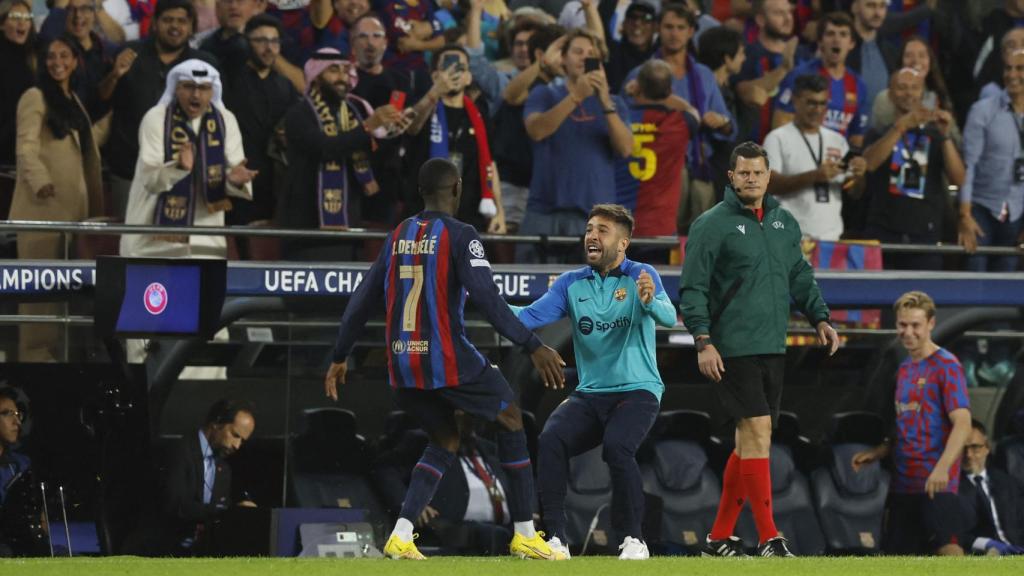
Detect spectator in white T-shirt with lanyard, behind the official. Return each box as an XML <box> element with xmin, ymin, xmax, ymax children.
<box><xmin>765</xmin><ymin>74</ymin><xmax>866</xmax><ymax>241</ymax></box>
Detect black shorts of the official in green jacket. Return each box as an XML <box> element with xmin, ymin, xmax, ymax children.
<box><xmin>714</xmin><ymin>354</ymin><xmax>785</xmax><ymax>426</ymax></box>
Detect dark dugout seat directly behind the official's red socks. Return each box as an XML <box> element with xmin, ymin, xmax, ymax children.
<box><xmin>736</xmin><ymin>444</ymin><xmax>825</xmax><ymax>556</ymax></box>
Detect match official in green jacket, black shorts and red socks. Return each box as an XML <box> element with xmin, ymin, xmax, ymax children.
<box><xmin>679</xmin><ymin>142</ymin><xmax>839</xmax><ymax>557</ymax></box>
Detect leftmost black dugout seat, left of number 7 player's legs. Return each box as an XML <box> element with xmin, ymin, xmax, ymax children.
<box><xmin>291</xmin><ymin>408</ymin><xmax>385</xmax><ymax>521</ymax></box>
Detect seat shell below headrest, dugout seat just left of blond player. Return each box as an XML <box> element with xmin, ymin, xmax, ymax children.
<box><xmin>811</xmin><ymin>444</ymin><xmax>889</xmax><ymax>553</ymax></box>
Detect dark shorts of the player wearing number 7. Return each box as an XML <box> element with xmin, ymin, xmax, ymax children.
<box><xmin>395</xmin><ymin>364</ymin><xmax>515</xmax><ymax>430</ymax></box>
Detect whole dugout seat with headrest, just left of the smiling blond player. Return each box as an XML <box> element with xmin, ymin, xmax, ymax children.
<box><xmin>811</xmin><ymin>412</ymin><xmax>889</xmax><ymax>554</ymax></box>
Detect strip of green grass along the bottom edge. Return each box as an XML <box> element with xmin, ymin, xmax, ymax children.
<box><xmin>0</xmin><ymin>558</ymin><xmax>1024</xmax><ymax>576</ymax></box>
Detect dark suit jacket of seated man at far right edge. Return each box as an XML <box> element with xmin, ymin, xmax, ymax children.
<box><xmin>959</xmin><ymin>467</ymin><xmax>1024</xmax><ymax>546</ymax></box>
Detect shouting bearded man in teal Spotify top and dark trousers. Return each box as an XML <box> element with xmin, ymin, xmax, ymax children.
<box><xmin>513</xmin><ymin>204</ymin><xmax>676</xmax><ymax>560</ymax></box>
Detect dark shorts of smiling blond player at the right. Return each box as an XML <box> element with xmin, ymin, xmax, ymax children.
<box><xmin>882</xmin><ymin>492</ymin><xmax>967</xmax><ymax>556</ymax></box>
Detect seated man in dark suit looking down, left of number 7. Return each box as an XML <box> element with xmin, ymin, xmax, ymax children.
<box><xmin>125</xmin><ymin>400</ymin><xmax>256</xmax><ymax>557</ymax></box>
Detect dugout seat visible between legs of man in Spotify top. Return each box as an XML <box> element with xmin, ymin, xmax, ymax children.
<box><xmin>565</xmin><ymin>446</ymin><xmax>618</xmax><ymax>553</ymax></box>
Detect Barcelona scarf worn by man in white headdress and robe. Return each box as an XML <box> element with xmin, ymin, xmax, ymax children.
<box><xmin>153</xmin><ymin>101</ymin><xmax>231</xmax><ymax>235</ymax></box>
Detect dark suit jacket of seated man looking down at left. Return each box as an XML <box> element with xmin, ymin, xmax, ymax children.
<box><xmin>126</xmin><ymin>431</ymin><xmax>231</xmax><ymax>556</ymax></box>
